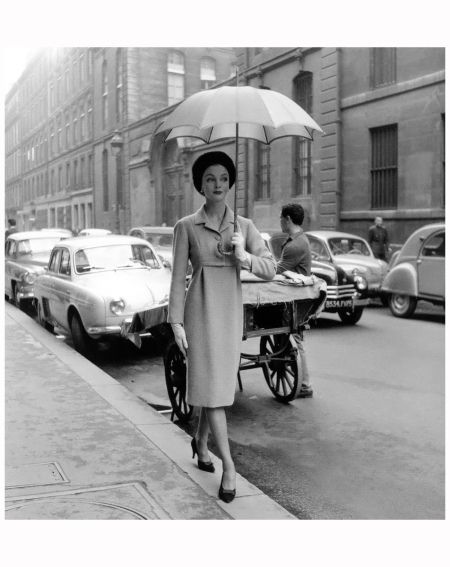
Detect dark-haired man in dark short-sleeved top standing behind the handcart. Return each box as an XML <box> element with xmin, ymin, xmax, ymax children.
<box><xmin>277</xmin><ymin>203</ymin><xmax>313</xmax><ymax>398</ymax></box>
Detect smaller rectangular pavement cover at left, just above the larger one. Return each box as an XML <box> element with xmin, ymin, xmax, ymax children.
<box><xmin>5</xmin><ymin>461</ymin><xmax>69</xmax><ymax>488</ymax></box>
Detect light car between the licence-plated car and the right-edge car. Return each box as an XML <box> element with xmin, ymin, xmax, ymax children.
<box><xmin>305</xmin><ymin>230</ymin><xmax>387</xmax><ymax>299</ymax></box>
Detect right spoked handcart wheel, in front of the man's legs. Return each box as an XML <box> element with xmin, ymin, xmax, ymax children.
<box><xmin>260</xmin><ymin>335</ymin><xmax>302</xmax><ymax>403</ymax></box>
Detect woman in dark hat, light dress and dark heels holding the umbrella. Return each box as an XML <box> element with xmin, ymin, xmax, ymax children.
<box><xmin>169</xmin><ymin>151</ymin><xmax>276</xmax><ymax>502</ymax></box>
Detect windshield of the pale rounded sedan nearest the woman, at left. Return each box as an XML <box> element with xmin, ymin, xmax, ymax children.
<box><xmin>75</xmin><ymin>244</ymin><xmax>161</xmax><ymax>273</ymax></box>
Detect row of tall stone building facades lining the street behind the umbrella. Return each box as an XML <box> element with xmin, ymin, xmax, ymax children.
<box><xmin>6</xmin><ymin>47</ymin><xmax>445</xmax><ymax>243</ymax></box>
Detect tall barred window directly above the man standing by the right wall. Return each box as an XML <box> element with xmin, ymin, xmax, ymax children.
<box><xmin>370</xmin><ymin>124</ymin><xmax>398</xmax><ymax>209</ymax></box>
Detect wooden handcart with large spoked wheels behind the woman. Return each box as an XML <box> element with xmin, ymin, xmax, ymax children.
<box><xmin>124</xmin><ymin>276</ymin><xmax>326</xmax><ymax>422</ymax></box>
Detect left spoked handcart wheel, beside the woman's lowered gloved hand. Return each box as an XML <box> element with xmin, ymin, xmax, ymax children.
<box><xmin>164</xmin><ymin>342</ymin><xmax>194</xmax><ymax>423</ymax></box>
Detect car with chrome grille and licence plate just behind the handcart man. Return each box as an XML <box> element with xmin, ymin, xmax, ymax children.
<box><xmin>261</xmin><ymin>232</ymin><xmax>369</xmax><ymax>325</ymax></box>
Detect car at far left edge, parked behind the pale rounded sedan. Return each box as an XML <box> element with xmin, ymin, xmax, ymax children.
<box><xmin>5</xmin><ymin>230</ymin><xmax>66</xmax><ymax>308</ymax></box>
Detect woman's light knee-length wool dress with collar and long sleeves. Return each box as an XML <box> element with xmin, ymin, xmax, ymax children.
<box><xmin>168</xmin><ymin>206</ymin><xmax>276</xmax><ymax>408</ymax></box>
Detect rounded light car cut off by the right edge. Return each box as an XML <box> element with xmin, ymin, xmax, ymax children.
<box><xmin>381</xmin><ymin>223</ymin><xmax>445</xmax><ymax>317</ymax></box>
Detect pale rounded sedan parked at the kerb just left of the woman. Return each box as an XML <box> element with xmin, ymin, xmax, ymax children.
<box><xmin>35</xmin><ymin>235</ymin><xmax>171</xmax><ymax>357</ymax></box>
